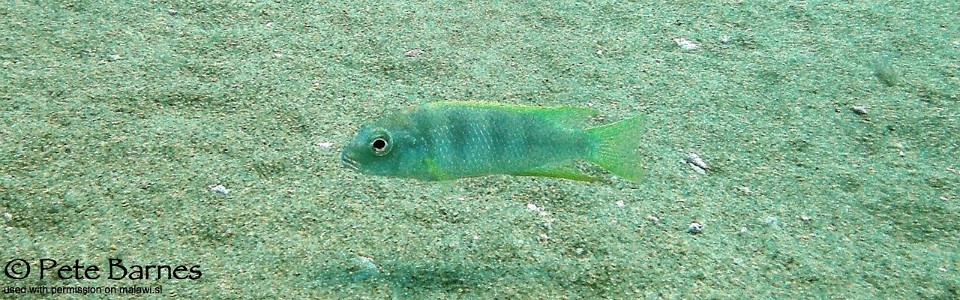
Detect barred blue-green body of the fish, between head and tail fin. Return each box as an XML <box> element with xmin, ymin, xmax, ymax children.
<box><xmin>412</xmin><ymin>108</ymin><xmax>587</xmax><ymax>177</ymax></box>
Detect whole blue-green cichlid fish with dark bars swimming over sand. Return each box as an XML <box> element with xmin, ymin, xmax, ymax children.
<box><xmin>340</xmin><ymin>102</ymin><xmax>644</xmax><ymax>182</ymax></box>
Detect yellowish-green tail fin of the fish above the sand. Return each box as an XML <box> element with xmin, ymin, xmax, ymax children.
<box><xmin>587</xmin><ymin>114</ymin><xmax>646</xmax><ymax>182</ymax></box>
